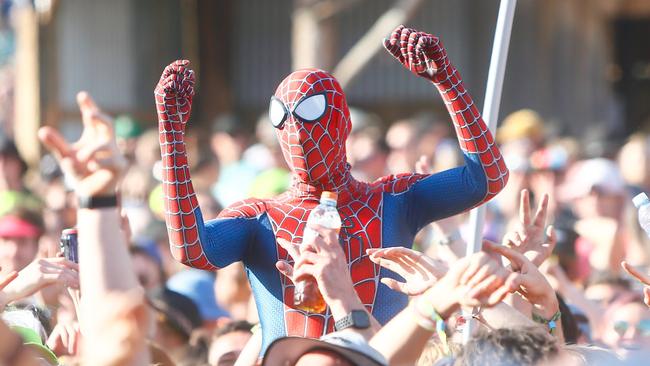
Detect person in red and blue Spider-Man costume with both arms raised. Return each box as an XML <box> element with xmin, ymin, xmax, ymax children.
<box><xmin>155</xmin><ymin>26</ymin><xmax>508</xmax><ymax>350</ymax></box>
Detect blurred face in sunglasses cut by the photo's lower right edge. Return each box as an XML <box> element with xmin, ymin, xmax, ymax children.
<box><xmin>603</xmin><ymin>303</ymin><xmax>650</xmax><ymax>350</ymax></box>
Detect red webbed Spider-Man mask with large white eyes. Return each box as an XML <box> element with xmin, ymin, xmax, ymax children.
<box><xmin>269</xmin><ymin>69</ymin><xmax>350</xmax><ymax>189</ymax></box>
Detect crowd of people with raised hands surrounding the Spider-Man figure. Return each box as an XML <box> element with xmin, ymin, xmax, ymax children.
<box><xmin>0</xmin><ymin>33</ymin><xmax>650</xmax><ymax>366</ymax></box>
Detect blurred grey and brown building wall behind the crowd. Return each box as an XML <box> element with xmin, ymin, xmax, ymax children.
<box><xmin>11</xmin><ymin>0</ymin><xmax>650</xmax><ymax>160</ymax></box>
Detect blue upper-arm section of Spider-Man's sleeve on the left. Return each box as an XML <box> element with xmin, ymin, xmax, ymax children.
<box><xmin>197</xmin><ymin>210</ymin><xmax>258</xmax><ymax>268</ymax></box>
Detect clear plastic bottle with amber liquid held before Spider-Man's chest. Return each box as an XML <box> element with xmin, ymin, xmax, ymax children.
<box><xmin>293</xmin><ymin>191</ymin><xmax>341</xmax><ymax>313</ymax></box>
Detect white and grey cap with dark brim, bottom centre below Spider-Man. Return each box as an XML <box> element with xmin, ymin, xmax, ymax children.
<box><xmin>262</xmin><ymin>332</ymin><xmax>388</xmax><ymax>366</ymax></box>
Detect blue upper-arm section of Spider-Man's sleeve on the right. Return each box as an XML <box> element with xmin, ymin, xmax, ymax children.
<box><xmin>402</xmin><ymin>153</ymin><xmax>487</xmax><ymax>233</ymax></box>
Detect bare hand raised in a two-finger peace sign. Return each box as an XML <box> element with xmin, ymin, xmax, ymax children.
<box><xmin>503</xmin><ymin>189</ymin><xmax>557</xmax><ymax>267</ymax></box>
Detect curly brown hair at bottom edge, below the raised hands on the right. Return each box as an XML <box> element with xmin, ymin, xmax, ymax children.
<box><xmin>454</xmin><ymin>327</ymin><xmax>559</xmax><ymax>366</ymax></box>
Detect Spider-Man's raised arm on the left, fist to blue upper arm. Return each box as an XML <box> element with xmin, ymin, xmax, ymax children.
<box><xmin>154</xmin><ymin>60</ymin><xmax>251</xmax><ymax>270</ymax></box>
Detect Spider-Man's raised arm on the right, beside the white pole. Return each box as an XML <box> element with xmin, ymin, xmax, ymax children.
<box><xmin>384</xmin><ymin>26</ymin><xmax>508</xmax><ymax>224</ymax></box>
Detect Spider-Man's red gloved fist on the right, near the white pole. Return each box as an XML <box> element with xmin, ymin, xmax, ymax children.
<box><xmin>384</xmin><ymin>25</ymin><xmax>449</xmax><ymax>81</ymax></box>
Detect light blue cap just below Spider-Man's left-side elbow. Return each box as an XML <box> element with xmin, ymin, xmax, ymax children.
<box><xmin>167</xmin><ymin>269</ymin><xmax>228</xmax><ymax>320</ymax></box>
